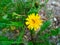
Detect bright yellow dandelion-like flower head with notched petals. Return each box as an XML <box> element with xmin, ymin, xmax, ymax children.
<box><xmin>26</xmin><ymin>13</ymin><xmax>43</xmax><ymax>31</ymax></box>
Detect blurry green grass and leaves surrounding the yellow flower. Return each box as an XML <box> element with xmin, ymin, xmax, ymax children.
<box><xmin>0</xmin><ymin>0</ymin><xmax>60</xmax><ymax>45</ymax></box>
